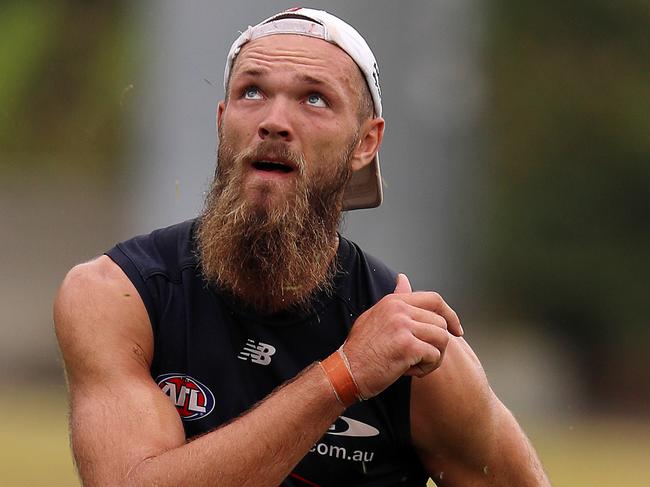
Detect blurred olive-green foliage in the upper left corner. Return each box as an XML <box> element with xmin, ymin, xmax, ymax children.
<box><xmin>0</xmin><ymin>0</ymin><xmax>133</xmax><ymax>174</ymax></box>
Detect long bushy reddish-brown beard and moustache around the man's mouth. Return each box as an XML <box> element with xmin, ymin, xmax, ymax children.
<box><xmin>197</xmin><ymin>139</ymin><xmax>356</xmax><ymax>314</ymax></box>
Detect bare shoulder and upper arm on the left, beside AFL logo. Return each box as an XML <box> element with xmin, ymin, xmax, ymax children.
<box><xmin>54</xmin><ymin>256</ymin><xmax>185</xmax><ymax>485</ymax></box>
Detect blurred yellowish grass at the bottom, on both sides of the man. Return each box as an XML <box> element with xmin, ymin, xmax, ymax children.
<box><xmin>0</xmin><ymin>387</ymin><xmax>650</xmax><ymax>487</ymax></box>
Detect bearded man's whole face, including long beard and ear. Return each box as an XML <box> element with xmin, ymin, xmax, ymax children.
<box><xmin>197</xmin><ymin>35</ymin><xmax>383</xmax><ymax>313</ymax></box>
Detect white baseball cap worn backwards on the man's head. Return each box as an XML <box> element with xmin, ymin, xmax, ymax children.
<box><xmin>223</xmin><ymin>7</ymin><xmax>383</xmax><ymax>210</ymax></box>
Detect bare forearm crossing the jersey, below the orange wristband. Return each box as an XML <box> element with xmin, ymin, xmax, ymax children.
<box><xmin>123</xmin><ymin>366</ymin><xmax>343</xmax><ymax>487</ymax></box>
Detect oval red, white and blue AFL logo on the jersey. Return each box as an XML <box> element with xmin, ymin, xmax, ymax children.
<box><xmin>156</xmin><ymin>374</ymin><xmax>214</xmax><ymax>421</ymax></box>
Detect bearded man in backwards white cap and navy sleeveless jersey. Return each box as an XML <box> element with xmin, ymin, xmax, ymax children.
<box><xmin>55</xmin><ymin>8</ymin><xmax>548</xmax><ymax>486</ymax></box>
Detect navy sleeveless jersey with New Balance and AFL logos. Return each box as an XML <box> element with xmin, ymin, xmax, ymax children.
<box><xmin>107</xmin><ymin>220</ymin><xmax>428</xmax><ymax>487</ymax></box>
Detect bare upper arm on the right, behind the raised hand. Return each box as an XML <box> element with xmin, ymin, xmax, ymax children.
<box><xmin>411</xmin><ymin>338</ymin><xmax>549</xmax><ymax>486</ymax></box>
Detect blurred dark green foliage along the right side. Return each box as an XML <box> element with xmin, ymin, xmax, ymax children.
<box><xmin>483</xmin><ymin>0</ymin><xmax>650</xmax><ymax>414</ymax></box>
